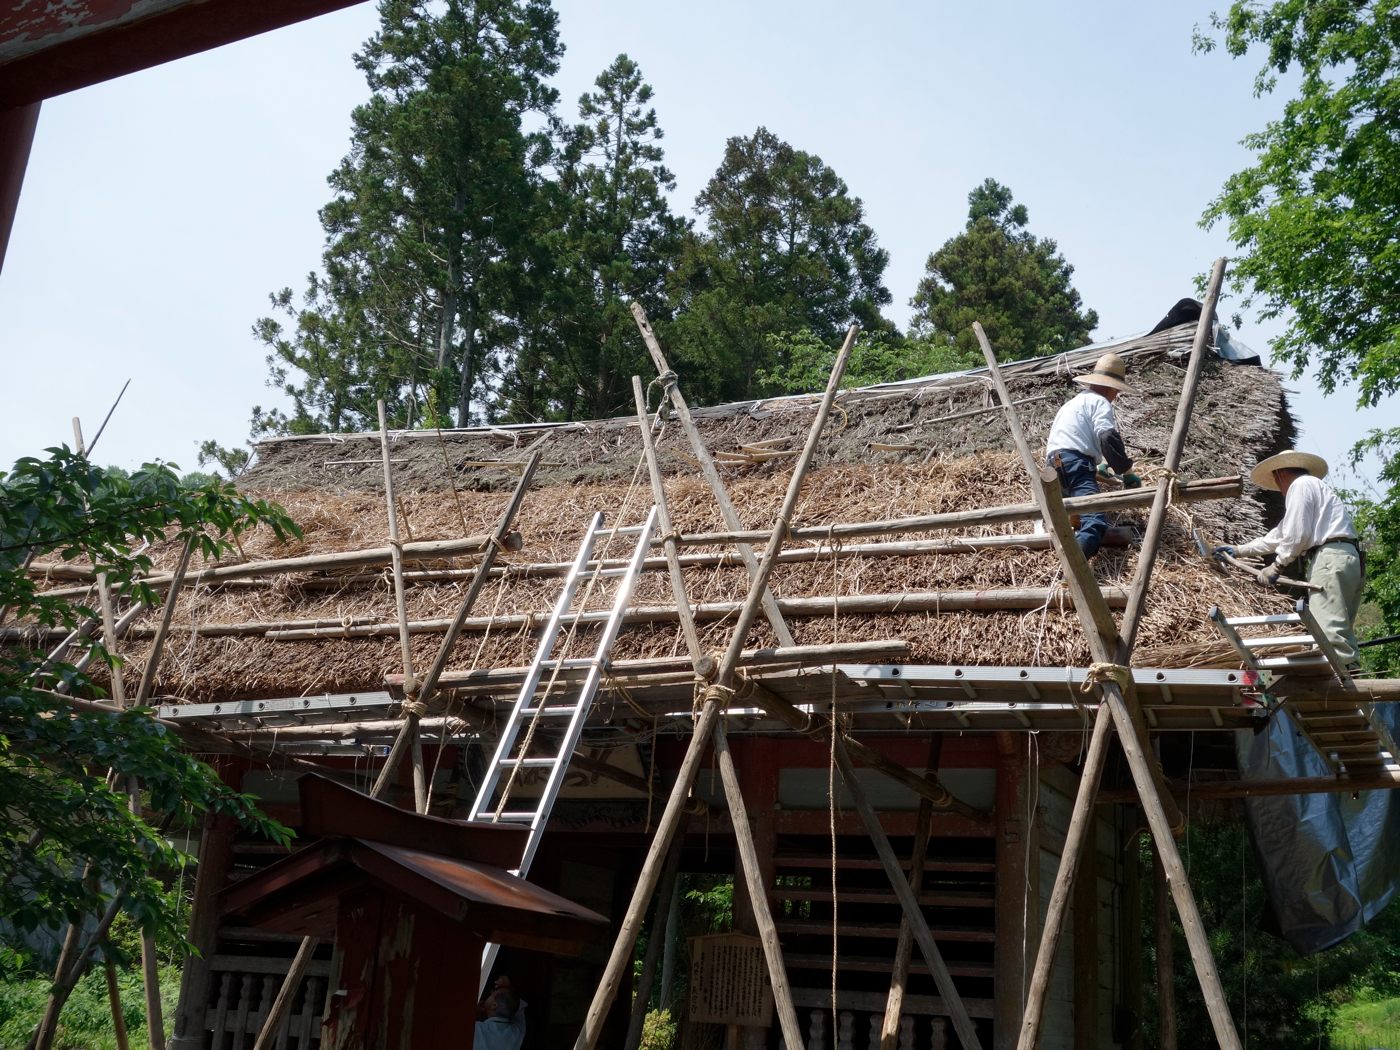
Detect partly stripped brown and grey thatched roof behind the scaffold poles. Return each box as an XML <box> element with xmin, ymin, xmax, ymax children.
<box><xmin>19</xmin><ymin>325</ymin><xmax>1292</xmax><ymax>701</ymax></box>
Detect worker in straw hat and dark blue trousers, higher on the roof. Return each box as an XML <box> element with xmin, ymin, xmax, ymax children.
<box><xmin>1046</xmin><ymin>353</ymin><xmax>1142</xmax><ymax>557</ymax></box>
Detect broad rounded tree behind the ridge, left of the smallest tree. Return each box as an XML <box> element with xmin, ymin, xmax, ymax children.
<box><xmin>671</xmin><ymin>127</ymin><xmax>890</xmax><ymax>399</ymax></box>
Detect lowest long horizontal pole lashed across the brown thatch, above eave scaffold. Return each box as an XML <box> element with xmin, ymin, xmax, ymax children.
<box><xmin>263</xmin><ymin>587</ymin><xmax>1127</xmax><ymax>641</ymax></box>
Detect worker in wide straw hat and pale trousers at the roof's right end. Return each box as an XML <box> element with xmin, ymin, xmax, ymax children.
<box><xmin>1217</xmin><ymin>448</ymin><xmax>1365</xmax><ymax>668</ymax></box>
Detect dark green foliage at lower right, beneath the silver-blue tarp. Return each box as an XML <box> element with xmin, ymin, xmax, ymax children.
<box><xmin>1140</xmin><ymin>820</ymin><xmax>1400</xmax><ymax>1050</ymax></box>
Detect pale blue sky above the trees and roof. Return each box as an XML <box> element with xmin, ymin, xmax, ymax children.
<box><xmin>0</xmin><ymin>0</ymin><xmax>1394</xmax><ymax>492</ymax></box>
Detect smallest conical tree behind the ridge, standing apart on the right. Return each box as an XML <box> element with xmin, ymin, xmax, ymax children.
<box><xmin>910</xmin><ymin>179</ymin><xmax>1099</xmax><ymax>360</ymax></box>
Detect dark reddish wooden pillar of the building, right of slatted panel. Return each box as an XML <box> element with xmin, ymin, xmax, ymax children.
<box><xmin>993</xmin><ymin>732</ymin><xmax>1040</xmax><ymax>1050</ymax></box>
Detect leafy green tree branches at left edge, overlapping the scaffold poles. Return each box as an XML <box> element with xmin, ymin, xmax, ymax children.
<box><xmin>0</xmin><ymin>448</ymin><xmax>297</xmax><ymax>1024</ymax></box>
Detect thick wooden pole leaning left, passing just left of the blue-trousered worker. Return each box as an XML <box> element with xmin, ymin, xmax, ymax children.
<box><xmin>973</xmin><ymin>312</ymin><xmax>1239</xmax><ymax>1050</ymax></box>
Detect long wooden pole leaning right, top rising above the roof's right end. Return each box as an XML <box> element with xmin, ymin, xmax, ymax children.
<box><xmin>1018</xmin><ymin>259</ymin><xmax>1225</xmax><ymax>1050</ymax></box>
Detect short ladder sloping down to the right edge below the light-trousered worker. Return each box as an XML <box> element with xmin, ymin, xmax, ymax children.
<box><xmin>1210</xmin><ymin>599</ymin><xmax>1400</xmax><ymax>777</ymax></box>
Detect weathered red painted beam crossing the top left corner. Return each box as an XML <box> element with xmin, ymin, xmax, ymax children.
<box><xmin>0</xmin><ymin>0</ymin><xmax>363</xmax><ymax>109</ymax></box>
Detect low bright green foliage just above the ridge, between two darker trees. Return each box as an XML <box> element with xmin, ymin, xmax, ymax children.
<box><xmin>757</xmin><ymin>328</ymin><xmax>981</xmax><ymax>396</ymax></box>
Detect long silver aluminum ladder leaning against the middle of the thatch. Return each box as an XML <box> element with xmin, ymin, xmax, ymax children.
<box><xmin>468</xmin><ymin>507</ymin><xmax>658</xmax><ymax>993</ymax></box>
